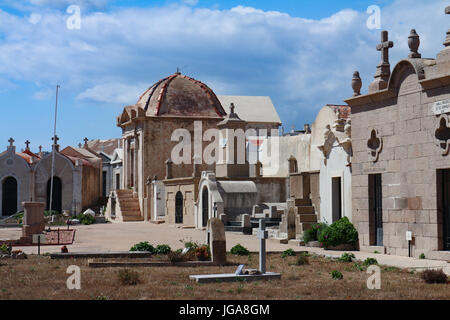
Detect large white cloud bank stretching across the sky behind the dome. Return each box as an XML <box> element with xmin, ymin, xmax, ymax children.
<box><xmin>0</xmin><ymin>0</ymin><xmax>450</xmax><ymax>126</ymax></box>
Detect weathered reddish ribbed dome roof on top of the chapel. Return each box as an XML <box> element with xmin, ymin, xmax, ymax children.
<box><xmin>136</xmin><ymin>72</ymin><xmax>226</xmax><ymax>118</ymax></box>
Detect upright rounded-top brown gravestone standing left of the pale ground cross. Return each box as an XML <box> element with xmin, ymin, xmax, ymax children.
<box><xmin>208</xmin><ymin>218</ymin><xmax>227</xmax><ymax>265</ymax></box>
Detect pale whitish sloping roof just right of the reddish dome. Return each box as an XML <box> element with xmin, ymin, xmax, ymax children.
<box><xmin>217</xmin><ymin>96</ymin><xmax>281</xmax><ymax>125</ymax></box>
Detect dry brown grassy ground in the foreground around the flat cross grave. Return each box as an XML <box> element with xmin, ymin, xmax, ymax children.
<box><xmin>0</xmin><ymin>253</ymin><xmax>450</xmax><ymax>300</ymax></box>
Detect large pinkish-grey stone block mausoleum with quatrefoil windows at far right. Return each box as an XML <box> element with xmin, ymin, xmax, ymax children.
<box><xmin>346</xmin><ymin>7</ymin><xmax>450</xmax><ymax>260</ymax></box>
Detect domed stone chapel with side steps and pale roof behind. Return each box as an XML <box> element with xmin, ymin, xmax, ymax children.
<box><xmin>107</xmin><ymin>71</ymin><xmax>284</xmax><ymax>225</ymax></box>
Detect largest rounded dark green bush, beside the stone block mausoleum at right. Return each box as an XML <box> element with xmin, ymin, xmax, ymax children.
<box><xmin>317</xmin><ymin>217</ymin><xmax>358</xmax><ymax>247</ymax></box>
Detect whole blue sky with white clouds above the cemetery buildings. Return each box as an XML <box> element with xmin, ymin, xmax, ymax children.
<box><xmin>0</xmin><ymin>0</ymin><xmax>450</xmax><ymax>151</ymax></box>
